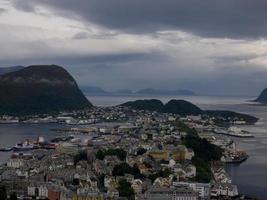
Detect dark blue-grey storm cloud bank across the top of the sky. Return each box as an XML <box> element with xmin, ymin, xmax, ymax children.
<box><xmin>14</xmin><ymin>0</ymin><xmax>267</xmax><ymax>38</ymax></box>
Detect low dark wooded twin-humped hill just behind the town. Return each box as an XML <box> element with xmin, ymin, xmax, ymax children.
<box><xmin>121</xmin><ymin>99</ymin><xmax>258</xmax><ymax>125</ymax></box>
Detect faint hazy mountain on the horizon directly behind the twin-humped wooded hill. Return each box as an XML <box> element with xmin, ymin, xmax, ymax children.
<box><xmin>136</xmin><ymin>88</ymin><xmax>196</xmax><ymax>96</ymax></box>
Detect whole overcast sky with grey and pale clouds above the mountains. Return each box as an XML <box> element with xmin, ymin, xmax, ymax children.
<box><xmin>0</xmin><ymin>0</ymin><xmax>267</xmax><ymax>96</ymax></box>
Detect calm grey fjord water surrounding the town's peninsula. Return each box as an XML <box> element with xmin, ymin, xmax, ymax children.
<box><xmin>0</xmin><ymin>96</ymin><xmax>267</xmax><ymax>199</ymax></box>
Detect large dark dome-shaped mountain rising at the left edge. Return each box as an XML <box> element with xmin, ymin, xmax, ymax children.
<box><xmin>0</xmin><ymin>65</ymin><xmax>92</xmax><ymax>115</ymax></box>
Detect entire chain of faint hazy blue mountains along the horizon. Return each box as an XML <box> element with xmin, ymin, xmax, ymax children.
<box><xmin>81</xmin><ymin>86</ymin><xmax>196</xmax><ymax>96</ymax></box>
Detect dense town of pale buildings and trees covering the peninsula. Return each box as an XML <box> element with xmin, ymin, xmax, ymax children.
<box><xmin>0</xmin><ymin>106</ymin><xmax>256</xmax><ymax>200</ymax></box>
